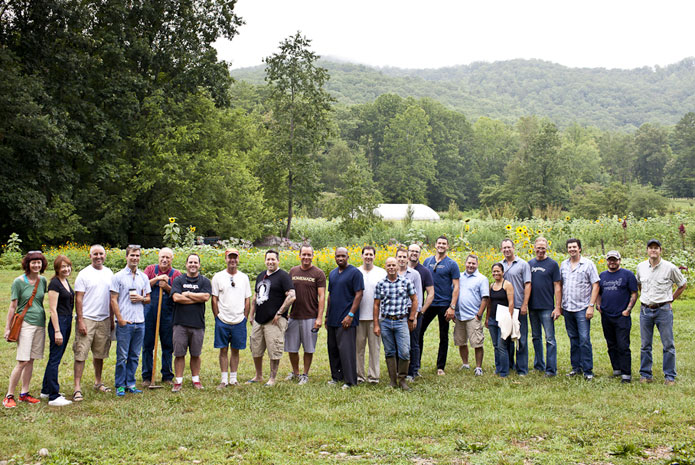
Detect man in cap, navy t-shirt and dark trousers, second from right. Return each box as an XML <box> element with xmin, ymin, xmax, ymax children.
<box><xmin>596</xmin><ymin>250</ymin><xmax>637</xmax><ymax>383</ymax></box>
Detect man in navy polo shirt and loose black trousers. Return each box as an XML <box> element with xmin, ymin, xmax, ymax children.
<box><xmin>326</xmin><ymin>247</ymin><xmax>364</xmax><ymax>389</ymax></box>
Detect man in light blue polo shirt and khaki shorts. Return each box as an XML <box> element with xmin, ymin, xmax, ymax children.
<box><xmin>454</xmin><ymin>255</ymin><xmax>490</xmax><ymax>376</ymax></box>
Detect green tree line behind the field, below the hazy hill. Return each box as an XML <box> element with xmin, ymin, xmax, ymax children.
<box><xmin>0</xmin><ymin>0</ymin><xmax>695</xmax><ymax>246</ymax></box>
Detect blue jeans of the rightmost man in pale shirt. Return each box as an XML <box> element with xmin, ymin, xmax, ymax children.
<box><xmin>640</xmin><ymin>303</ymin><xmax>676</xmax><ymax>381</ymax></box>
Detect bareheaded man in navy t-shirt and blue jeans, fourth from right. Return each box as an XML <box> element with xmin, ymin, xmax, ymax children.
<box><xmin>528</xmin><ymin>237</ymin><xmax>562</xmax><ymax>376</ymax></box>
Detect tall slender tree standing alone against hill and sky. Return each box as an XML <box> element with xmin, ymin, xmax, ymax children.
<box><xmin>259</xmin><ymin>31</ymin><xmax>333</xmax><ymax>237</ymax></box>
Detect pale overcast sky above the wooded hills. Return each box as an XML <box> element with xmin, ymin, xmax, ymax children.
<box><xmin>216</xmin><ymin>0</ymin><xmax>695</xmax><ymax>68</ymax></box>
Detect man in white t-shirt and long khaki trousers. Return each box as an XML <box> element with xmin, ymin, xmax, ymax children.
<box><xmin>356</xmin><ymin>245</ymin><xmax>386</xmax><ymax>383</ymax></box>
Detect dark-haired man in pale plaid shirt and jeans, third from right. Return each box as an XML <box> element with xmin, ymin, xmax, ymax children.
<box><xmin>560</xmin><ymin>238</ymin><xmax>599</xmax><ymax>381</ymax></box>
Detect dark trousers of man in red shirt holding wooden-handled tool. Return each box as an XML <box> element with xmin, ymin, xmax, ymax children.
<box><xmin>142</xmin><ymin>304</ymin><xmax>174</xmax><ymax>381</ymax></box>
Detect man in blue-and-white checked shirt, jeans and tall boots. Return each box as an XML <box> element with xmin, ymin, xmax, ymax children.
<box><xmin>374</xmin><ymin>257</ymin><xmax>418</xmax><ymax>391</ymax></box>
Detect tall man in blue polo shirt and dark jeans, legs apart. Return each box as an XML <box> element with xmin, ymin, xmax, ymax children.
<box><xmin>420</xmin><ymin>236</ymin><xmax>461</xmax><ymax>376</ymax></box>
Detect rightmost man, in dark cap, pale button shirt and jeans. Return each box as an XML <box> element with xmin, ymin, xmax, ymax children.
<box><xmin>636</xmin><ymin>239</ymin><xmax>686</xmax><ymax>386</ymax></box>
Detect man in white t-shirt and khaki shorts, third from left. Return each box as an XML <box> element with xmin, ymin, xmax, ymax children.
<box><xmin>72</xmin><ymin>244</ymin><xmax>114</xmax><ymax>402</ymax></box>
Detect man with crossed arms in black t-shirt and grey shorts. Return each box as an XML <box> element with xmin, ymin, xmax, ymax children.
<box><xmin>171</xmin><ymin>254</ymin><xmax>212</xmax><ymax>392</ymax></box>
